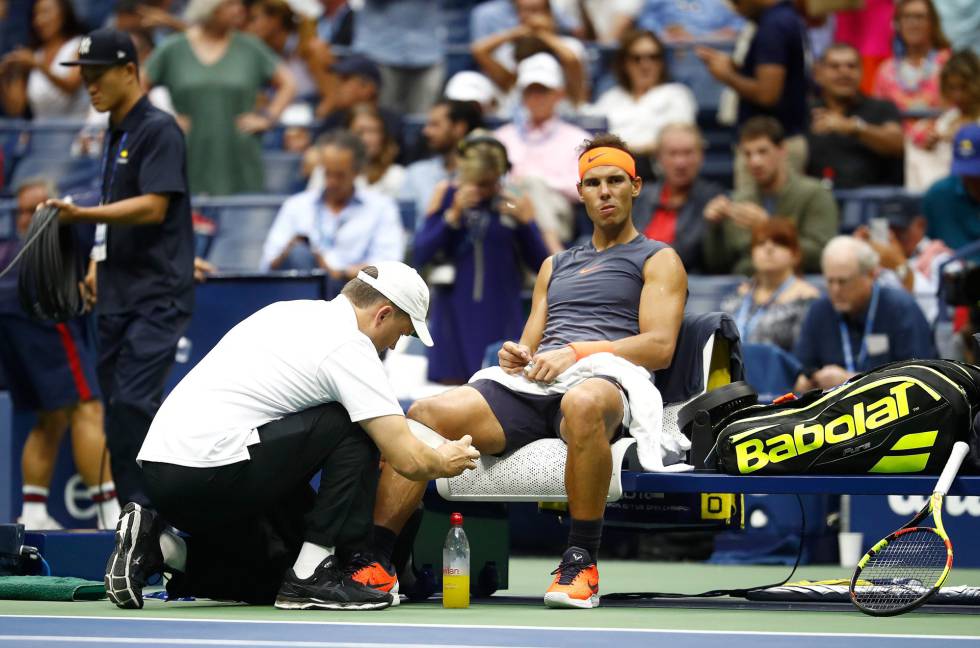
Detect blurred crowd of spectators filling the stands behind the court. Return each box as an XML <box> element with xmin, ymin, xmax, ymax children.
<box><xmin>0</xmin><ymin>0</ymin><xmax>980</xmax><ymax>556</ymax></box>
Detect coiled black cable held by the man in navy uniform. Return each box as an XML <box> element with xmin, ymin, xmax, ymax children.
<box><xmin>11</xmin><ymin>206</ymin><xmax>85</xmax><ymax>322</ymax></box>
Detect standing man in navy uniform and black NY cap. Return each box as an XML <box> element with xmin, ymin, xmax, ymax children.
<box><xmin>48</xmin><ymin>29</ymin><xmax>194</xmax><ymax>505</ymax></box>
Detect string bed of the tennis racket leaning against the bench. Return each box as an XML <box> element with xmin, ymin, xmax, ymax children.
<box><xmin>854</xmin><ymin>529</ymin><xmax>948</xmax><ymax>611</ymax></box>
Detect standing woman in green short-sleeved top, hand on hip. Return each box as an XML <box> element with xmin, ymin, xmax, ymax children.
<box><xmin>146</xmin><ymin>0</ymin><xmax>296</xmax><ymax>195</ymax></box>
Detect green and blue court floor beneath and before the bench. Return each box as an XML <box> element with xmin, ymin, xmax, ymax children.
<box><xmin>0</xmin><ymin>557</ymin><xmax>980</xmax><ymax>648</ymax></box>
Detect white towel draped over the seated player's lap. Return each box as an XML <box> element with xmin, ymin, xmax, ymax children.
<box><xmin>470</xmin><ymin>353</ymin><xmax>694</xmax><ymax>472</ymax></box>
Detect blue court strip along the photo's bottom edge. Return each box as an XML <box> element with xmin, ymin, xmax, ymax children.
<box><xmin>0</xmin><ymin>616</ymin><xmax>980</xmax><ymax>648</ymax></box>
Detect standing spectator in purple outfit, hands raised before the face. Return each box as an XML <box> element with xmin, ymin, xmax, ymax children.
<box><xmin>414</xmin><ymin>130</ymin><xmax>548</xmax><ymax>384</ymax></box>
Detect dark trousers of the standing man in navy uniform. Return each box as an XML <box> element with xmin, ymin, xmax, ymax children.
<box><xmin>98</xmin><ymin>304</ymin><xmax>191</xmax><ymax>506</ymax></box>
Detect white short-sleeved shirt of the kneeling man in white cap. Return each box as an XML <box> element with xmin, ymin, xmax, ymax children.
<box><xmin>137</xmin><ymin>295</ymin><xmax>404</xmax><ymax>468</ymax></box>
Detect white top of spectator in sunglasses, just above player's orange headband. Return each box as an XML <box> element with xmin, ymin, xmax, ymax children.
<box><xmin>584</xmin><ymin>83</ymin><xmax>698</xmax><ymax>148</ymax></box>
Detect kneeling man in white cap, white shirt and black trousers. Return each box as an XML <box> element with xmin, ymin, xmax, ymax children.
<box><xmin>105</xmin><ymin>262</ymin><xmax>479</xmax><ymax>609</ymax></box>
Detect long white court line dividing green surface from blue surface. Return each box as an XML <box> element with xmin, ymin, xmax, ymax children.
<box><xmin>0</xmin><ymin>614</ymin><xmax>980</xmax><ymax>648</ymax></box>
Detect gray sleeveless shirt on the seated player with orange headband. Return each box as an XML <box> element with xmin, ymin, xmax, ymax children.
<box><xmin>537</xmin><ymin>234</ymin><xmax>669</xmax><ymax>353</ymax></box>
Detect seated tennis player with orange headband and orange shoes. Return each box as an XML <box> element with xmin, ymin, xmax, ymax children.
<box><xmin>353</xmin><ymin>134</ymin><xmax>687</xmax><ymax>608</ymax></box>
